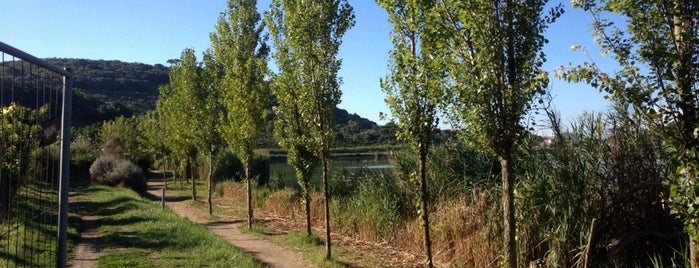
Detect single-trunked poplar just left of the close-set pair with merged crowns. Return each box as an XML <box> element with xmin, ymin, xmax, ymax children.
<box><xmin>211</xmin><ymin>0</ymin><xmax>271</xmax><ymax>228</ymax></box>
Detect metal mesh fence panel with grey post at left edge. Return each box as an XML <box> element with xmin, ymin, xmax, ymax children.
<box><xmin>0</xmin><ymin>42</ymin><xmax>72</xmax><ymax>267</ymax></box>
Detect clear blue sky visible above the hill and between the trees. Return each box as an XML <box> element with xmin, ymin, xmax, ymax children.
<box><xmin>0</xmin><ymin>0</ymin><xmax>609</xmax><ymax>132</ymax></box>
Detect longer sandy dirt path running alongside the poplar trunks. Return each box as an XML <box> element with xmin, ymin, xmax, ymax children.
<box><xmin>148</xmin><ymin>179</ymin><xmax>314</xmax><ymax>268</ymax></box>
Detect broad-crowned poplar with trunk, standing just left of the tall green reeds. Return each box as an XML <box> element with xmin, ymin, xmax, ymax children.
<box><xmin>441</xmin><ymin>0</ymin><xmax>563</xmax><ymax>267</ymax></box>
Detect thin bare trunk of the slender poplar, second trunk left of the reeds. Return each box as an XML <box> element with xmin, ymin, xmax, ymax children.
<box><xmin>418</xmin><ymin>145</ymin><xmax>434</xmax><ymax>268</ymax></box>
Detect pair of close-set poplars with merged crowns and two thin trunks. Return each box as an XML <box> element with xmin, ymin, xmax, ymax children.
<box><xmin>266</xmin><ymin>0</ymin><xmax>354</xmax><ymax>255</ymax></box>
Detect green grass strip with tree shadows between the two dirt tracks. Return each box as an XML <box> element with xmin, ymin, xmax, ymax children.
<box><xmin>75</xmin><ymin>185</ymin><xmax>265</xmax><ymax>267</ymax></box>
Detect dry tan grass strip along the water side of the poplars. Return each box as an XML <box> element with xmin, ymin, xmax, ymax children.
<box><xmin>258</xmin><ymin>185</ymin><xmax>500</xmax><ymax>267</ymax></box>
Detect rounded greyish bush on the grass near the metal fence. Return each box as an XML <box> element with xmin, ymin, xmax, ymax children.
<box><xmin>90</xmin><ymin>155</ymin><xmax>148</xmax><ymax>195</ymax></box>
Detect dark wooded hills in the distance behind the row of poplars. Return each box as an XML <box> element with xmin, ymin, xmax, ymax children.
<box><xmin>46</xmin><ymin>58</ymin><xmax>396</xmax><ymax>147</ymax></box>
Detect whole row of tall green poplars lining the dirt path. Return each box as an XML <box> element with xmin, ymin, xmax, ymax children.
<box><xmin>83</xmin><ymin>0</ymin><xmax>699</xmax><ymax>267</ymax></box>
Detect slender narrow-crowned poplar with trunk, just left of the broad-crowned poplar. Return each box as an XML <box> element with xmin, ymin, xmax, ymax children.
<box><xmin>377</xmin><ymin>0</ymin><xmax>446</xmax><ymax>267</ymax></box>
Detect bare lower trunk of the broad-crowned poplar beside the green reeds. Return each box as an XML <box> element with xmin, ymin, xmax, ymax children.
<box><xmin>499</xmin><ymin>150</ymin><xmax>517</xmax><ymax>268</ymax></box>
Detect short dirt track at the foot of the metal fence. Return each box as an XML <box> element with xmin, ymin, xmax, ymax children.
<box><xmin>68</xmin><ymin>195</ymin><xmax>104</xmax><ymax>268</ymax></box>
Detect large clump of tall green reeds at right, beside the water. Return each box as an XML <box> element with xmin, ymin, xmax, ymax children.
<box><xmin>516</xmin><ymin>108</ymin><xmax>682</xmax><ymax>267</ymax></box>
